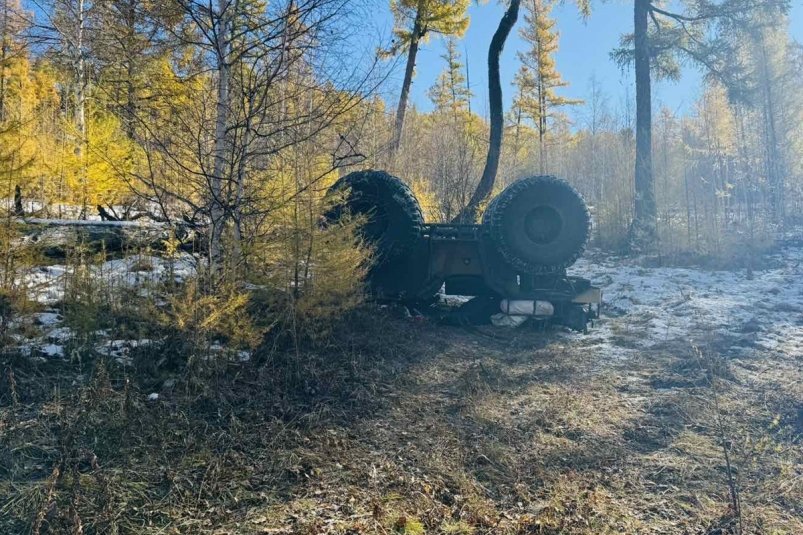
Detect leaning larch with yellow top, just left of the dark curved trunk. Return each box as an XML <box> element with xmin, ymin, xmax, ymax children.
<box><xmin>387</xmin><ymin>0</ymin><xmax>469</xmax><ymax>151</ymax></box>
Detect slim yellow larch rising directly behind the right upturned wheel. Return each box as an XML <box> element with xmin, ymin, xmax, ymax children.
<box><xmin>514</xmin><ymin>0</ymin><xmax>582</xmax><ymax>174</ymax></box>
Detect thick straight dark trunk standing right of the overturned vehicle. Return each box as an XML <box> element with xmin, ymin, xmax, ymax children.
<box><xmin>630</xmin><ymin>0</ymin><xmax>658</xmax><ymax>252</ymax></box>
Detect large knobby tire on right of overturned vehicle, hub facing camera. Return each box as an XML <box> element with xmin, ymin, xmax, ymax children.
<box><xmin>482</xmin><ymin>176</ymin><xmax>591</xmax><ymax>273</ymax></box>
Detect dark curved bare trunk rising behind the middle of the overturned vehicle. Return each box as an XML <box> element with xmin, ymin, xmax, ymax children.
<box><xmin>455</xmin><ymin>0</ymin><xmax>521</xmax><ymax>223</ymax></box>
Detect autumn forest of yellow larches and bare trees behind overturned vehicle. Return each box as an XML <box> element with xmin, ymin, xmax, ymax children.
<box><xmin>0</xmin><ymin>0</ymin><xmax>803</xmax><ymax>273</ymax></box>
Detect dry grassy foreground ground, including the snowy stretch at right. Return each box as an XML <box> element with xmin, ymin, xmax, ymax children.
<box><xmin>0</xmin><ymin>246</ymin><xmax>803</xmax><ymax>534</ymax></box>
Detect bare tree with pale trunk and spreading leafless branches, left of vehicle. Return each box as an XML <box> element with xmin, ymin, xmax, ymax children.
<box><xmin>167</xmin><ymin>0</ymin><xmax>376</xmax><ymax>271</ymax></box>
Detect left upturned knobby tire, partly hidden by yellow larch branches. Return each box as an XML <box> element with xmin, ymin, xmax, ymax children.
<box><xmin>326</xmin><ymin>171</ymin><xmax>424</xmax><ymax>264</ymax></box>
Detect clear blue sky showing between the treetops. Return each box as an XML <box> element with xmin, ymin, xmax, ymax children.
<box><xmin>376</xmin><ymin>0</ymin><xmax>803</xmax><ymax>122</ymax></box>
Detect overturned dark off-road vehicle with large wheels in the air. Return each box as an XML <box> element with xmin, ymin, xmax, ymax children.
<box><xmin>327</xmin><ymin>171</ymin><xmax>602</xmax><ymax>331</ymax></box>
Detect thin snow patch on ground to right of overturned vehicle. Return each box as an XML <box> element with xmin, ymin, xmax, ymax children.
<box><xmin>571</xmin><ymin>246</ymin><xmax>803</xmax><ymax>357</ymax></box>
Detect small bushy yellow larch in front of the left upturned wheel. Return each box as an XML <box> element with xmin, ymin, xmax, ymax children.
<box><xmin>234</xmin><ymin>133</ymin><xmax>368</xmax><ymax>336</ymax></box>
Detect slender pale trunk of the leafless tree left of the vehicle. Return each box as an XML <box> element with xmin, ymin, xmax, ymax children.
<box><xmin>209</xmin><ymin>0</ymin><xmax>231</xmax><ymax>269</ymax></box>
